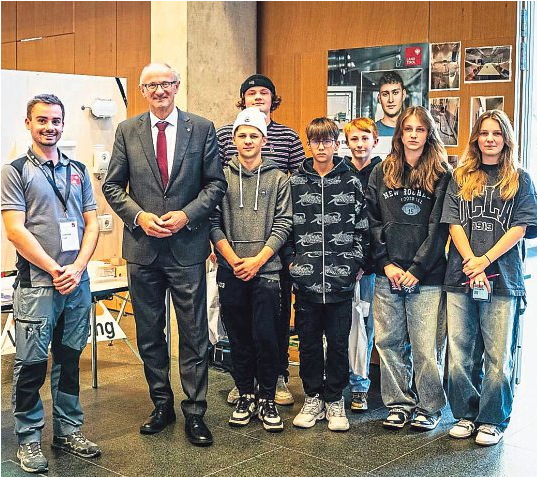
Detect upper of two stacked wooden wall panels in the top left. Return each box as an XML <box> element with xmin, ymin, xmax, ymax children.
<box><xmin>17</xmin><ymin>2</ymin><xmax>75</xmax><ymax>40</ymax></box>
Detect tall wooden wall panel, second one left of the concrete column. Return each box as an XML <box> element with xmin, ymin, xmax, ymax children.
<box><xmin>75</xmin><ymin>2</ymin><xmax>117</xmax><ymax>76</ymax></box>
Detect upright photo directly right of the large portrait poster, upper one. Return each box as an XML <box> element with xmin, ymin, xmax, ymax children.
<box><xmin>429</xmin><ymin>41</ymin><xmax>461</xmax><ymax>91</ymax></box>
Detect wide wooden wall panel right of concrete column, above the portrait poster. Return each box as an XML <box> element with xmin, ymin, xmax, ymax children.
<box><xmin>258</xmin><ymin>2</ymin><xmax>429</xmax><ymax>57</ymax></box>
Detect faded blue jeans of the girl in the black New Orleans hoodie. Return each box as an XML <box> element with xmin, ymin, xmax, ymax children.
<box><xmin>373</xmin><ymin>276</ymin><xmax>446</xmax><ymax>415</ymax></box>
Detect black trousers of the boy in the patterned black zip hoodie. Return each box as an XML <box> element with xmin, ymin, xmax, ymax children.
<box><xmin>295</xmin><ymin>292</ymin><xmax>352</xmax><ymax>402</ymax></box>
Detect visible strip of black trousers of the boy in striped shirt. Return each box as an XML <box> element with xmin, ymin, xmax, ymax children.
<box><xmin>276</xmin><ymin>252</ymin><xmax>292</xmax><ymax>378</ymax></box>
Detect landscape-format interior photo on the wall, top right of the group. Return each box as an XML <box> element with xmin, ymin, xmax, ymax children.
<box><xmin>464</xmin><ymin>45</ymin><xmax>512</xmax><ymax>83</ymax></box>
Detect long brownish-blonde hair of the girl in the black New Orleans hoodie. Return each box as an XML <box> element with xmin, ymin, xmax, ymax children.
<box><xmin>382</xmin><ymin>106</ymin><xmax>449</xmax><ymax>194</ymax></box>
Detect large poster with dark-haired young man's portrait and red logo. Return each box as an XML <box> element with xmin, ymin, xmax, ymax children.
<box><xmin>327</xmin><ymin>43</ymin><xmax>429</xmax><ymax>157</ymax></box>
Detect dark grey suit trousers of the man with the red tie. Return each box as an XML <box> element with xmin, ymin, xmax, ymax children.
<box><xmin>127</xmin><ymin>242</ymin><xmax>209</xmax><ymax>416</ymax></box>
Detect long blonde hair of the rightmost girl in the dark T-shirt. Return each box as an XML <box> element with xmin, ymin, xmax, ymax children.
<box><xmin>453</xmin><ymin>109</ymin><xmax>519</xmax><ymax>201</ymax></box>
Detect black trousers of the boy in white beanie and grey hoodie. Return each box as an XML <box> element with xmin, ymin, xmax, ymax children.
<box><xmin>216</xmin><ymin>267</ymin><xmax>280</xmax><ymax>399</ymax></box>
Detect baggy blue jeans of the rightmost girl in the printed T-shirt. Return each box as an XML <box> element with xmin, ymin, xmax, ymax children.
<box><xmin>447</xmin><ymin>292</ymin><xmax>520</xmax><ymax>429</ymax></box>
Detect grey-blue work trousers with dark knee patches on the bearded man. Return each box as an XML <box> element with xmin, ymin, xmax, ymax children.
<box><xmin>13</xmin><ymin>280</ymin><xmax>91</xmax><ymax>444</ymax></box>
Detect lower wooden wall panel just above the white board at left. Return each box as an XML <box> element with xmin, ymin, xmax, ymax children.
<box><xmin>17</xmin><ymin>34</ymin><xmax>75</xmax><ymax>74</ymax></box>
